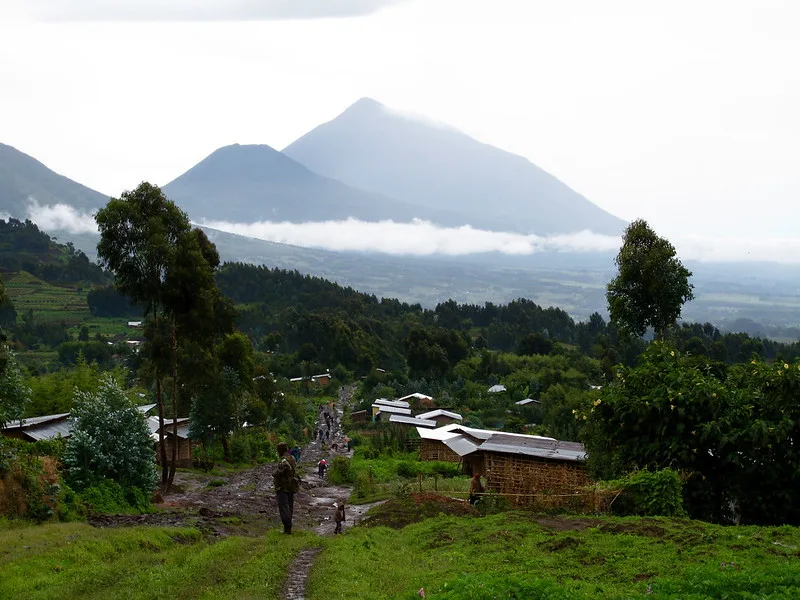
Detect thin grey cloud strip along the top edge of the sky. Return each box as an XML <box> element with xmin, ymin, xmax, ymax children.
<box><xmin>21</xmin><ymin>0</ymin><xmax>405</xmax><ymax>21</ymax></box>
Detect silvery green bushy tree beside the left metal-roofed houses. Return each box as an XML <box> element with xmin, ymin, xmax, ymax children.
<box><xmin>64</xmin><ymin>376</ymin><xmax>156</xmax><ymax>492</ymax></box>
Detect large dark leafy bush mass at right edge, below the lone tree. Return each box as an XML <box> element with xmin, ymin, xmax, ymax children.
<box><xmin>576</xmin><ymin>343</ymin><xmax>800</xmax><ymax>523</ymax></box>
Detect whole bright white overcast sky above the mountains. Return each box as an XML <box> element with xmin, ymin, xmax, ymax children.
<box><xmin>0</xmin><ymin>0</ymin><xmax>800</xmax><ymax>246</ymax></box>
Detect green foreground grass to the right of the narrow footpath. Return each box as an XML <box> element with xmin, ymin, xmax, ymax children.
<box><xmin>307</xmin><ymin>505</ymin><xmax>800</xmax><ymax>600</ymax></box>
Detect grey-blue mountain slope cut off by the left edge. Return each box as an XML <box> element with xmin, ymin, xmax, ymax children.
<box><xmin>0</xmin><ymin>144</ymin><xmax>108</xmax><ymax>219</ymax></box>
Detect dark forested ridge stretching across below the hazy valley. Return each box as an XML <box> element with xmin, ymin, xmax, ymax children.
<box><xmin>212</xmin><ymin>263</ymin><xmax>800</xmax><ymax>376</ymax></box>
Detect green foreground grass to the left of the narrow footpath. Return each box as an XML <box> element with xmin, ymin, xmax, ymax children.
<box><xmin>0</xmin><ymin>523</ymin><xmax>317</xmax><ymax>600</ymax></box>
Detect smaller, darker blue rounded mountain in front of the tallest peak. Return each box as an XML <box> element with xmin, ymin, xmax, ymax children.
<box><xmin>164</xmin><ymin>144</ymin><xmax>476</xmax><ymax>225</ymax></box>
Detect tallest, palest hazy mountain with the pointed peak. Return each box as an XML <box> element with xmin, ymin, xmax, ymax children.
<box><xmin>283</xmin><ymin>98</ymin><xmax>625</xmax><ymax>235</ymax></box>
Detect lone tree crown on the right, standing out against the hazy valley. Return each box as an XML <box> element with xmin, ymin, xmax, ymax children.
<box><xmin>606</xmin><ymin>219</ymin><xmax>694</xmax><ymax>339</ymax></box>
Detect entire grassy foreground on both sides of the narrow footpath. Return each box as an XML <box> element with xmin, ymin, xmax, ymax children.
<box><xmin>0</xmin><ymin>505</ymin><xmax>800</xmax><ymax>600</ymax></box>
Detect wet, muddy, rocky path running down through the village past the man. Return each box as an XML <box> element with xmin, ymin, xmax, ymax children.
<box><xmin>89</xmin><ymin>386</ymin><xmax>370</xmax><ymax>536</ymax></box>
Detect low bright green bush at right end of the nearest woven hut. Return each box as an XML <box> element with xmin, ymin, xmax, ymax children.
<box><xmin>600</xmin><ymin>469</ymin><xmax>686</xmax><ymax>517</ymax></box>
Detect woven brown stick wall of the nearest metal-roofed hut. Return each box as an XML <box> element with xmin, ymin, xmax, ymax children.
<box><xmin>480</xmin><ymin>452</ymin><xmax>589</xmax><ymax>506</ymax></box>
